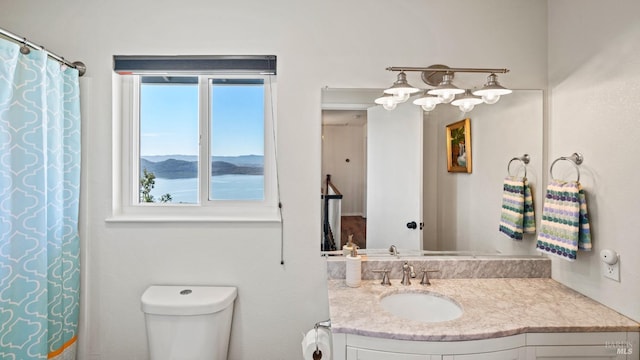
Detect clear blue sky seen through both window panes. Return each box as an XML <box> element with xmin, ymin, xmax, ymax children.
<box><xmin>140</xmin><ymin>84</ymin><xmax>264</xmax><ymax>156</ymax></box>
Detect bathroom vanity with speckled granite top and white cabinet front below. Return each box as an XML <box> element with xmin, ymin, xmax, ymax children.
<box><xmin>328</xmin><ymin>259</ymin><xmax>640</xmax><ymax>360</ymax></box>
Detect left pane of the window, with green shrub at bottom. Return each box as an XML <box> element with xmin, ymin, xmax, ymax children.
<box><xmin>139</xmin><ymin>76</ymin><xmax>200</xmax><ymax>205</ymax></box>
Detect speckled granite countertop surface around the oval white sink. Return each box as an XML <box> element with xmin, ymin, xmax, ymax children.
<box><xmin>328</xmin><ymin>278</ymin><xmax>640</xmax><ymax>341</ymax></box>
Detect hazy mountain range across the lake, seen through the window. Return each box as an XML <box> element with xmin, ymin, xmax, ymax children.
<box><xmin>140</xmin><ymin>155</ymin><xmax>264</xmax><ymax>179</ymax></box>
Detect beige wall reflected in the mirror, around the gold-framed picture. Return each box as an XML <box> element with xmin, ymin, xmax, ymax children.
<box><xmin>424</xmin><ymin>90</ymin><xmax>546</xmax><ymax>255</ymax></box>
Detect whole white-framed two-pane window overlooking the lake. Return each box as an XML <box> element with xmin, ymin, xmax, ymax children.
<box><xmin>112</xmin><ymin>57</ymin><xmax>278</xmax><ymax>221</ymax></box>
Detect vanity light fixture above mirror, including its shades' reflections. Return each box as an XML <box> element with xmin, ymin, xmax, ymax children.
<box><xmin>375</xmin><ymin>65</ymin><xmax>512</xmax><ymax>112</ymax></box>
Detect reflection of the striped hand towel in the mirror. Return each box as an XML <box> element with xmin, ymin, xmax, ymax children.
<box><xmin>500</xmin><ymin>176</ymin><xmax>536</xmax><ymax>240</ymax></box>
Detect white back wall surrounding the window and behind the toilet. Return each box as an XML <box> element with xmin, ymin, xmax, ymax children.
<box><xmin>0</xmin><ymin>0</ymin><xmax>552</xmax><ymax>360</ymax></box>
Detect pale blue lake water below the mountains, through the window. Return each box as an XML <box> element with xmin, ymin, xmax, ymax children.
<box><xmin>151</xmin><ymin>175</ymin><xmax>264</xmax><ymax>204</ymax></box>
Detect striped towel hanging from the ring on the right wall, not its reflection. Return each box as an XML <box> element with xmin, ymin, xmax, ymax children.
<box><xmin>536</xmin><ymin>180</ymin><xmax>591</xmax><ymax>261</ymax></box>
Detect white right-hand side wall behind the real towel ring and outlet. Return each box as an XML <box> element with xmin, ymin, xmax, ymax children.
<box><xmin>548</xmin><ymin>0</ymin><xmax>640</xmax><ymax>320</ymax></box>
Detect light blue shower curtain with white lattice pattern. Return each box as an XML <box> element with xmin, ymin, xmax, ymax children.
<box><xmin>0</xmin><ymin>39</ymin><xmax>80</xmax><ymax>359</ymax></box>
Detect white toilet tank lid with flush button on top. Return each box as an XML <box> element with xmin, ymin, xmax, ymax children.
<box><xmin>140</xmin><ymin>285</ymin><xmax>237</xmax><ymax>315</ymax></box>
